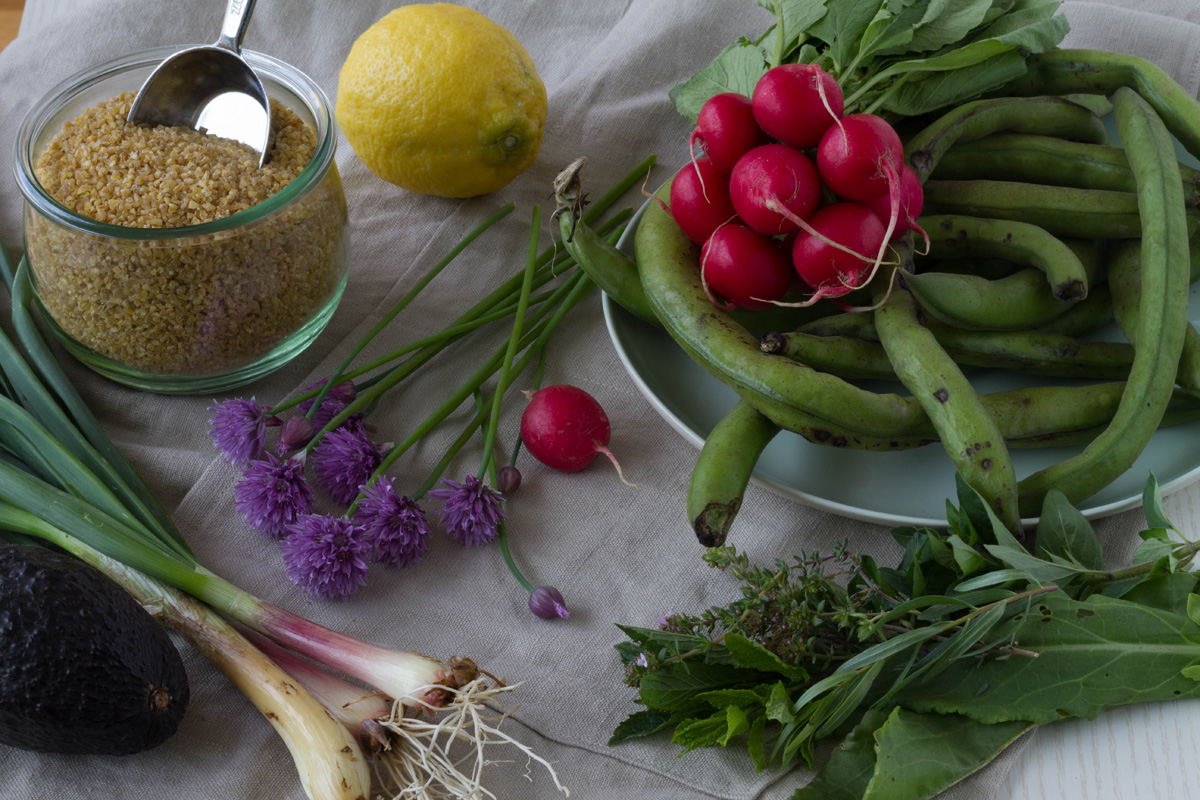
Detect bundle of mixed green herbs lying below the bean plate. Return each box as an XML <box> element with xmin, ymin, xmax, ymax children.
<box><xmin>610</xmin><ymin>476</ymin><xmax>1200</xmax><ymax>800</ymax></box>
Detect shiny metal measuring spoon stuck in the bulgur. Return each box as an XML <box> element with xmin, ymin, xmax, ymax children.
<box><xmin>126</xmin><ymin>0</ymin><xmax>271</xmax><ymax>167</ymax></box>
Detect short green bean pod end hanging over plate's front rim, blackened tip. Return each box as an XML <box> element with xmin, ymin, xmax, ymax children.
<box><xmin>688</xmin><ymin>401</ymin><xmax>780</xmax><ymax>547</ymax></box>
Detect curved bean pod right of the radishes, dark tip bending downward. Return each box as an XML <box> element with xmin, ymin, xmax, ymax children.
<box><xmin>920</xmin><ymin>215</ymin><xmax>1094</xmax><ymax>302</ymax></box>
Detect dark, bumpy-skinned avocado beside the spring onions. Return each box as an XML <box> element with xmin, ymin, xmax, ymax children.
<box><xmin>0</xmin><ymin>542</ymin><xmax>190</xmax><ymax>756</ymax></box>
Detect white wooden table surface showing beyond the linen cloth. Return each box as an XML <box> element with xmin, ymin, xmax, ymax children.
<box><xmin>7</xmin><ymin>0</ymin><xmax>1200</xmax><ymax>800</ymax></box>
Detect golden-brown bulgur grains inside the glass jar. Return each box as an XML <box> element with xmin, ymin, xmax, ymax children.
<box><xmin>26</xmin><ymin>92</ymin><xmax>347</xmax><ymax>375</ymax></box>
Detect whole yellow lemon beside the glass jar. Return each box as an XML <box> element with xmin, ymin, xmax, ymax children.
<box><xmin>336</xmin><ymin>2</ymin><xmax>546</xmax><ymax>197</ymax></box>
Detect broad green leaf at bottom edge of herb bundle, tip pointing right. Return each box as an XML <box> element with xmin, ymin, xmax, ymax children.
<box><xmin>864</xmin><ymin>709</ymin><xmax>1033</xmax><ymax>800</ymax></box>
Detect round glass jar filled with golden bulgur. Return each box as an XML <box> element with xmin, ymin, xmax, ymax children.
<box><xmin>17</xmin><ymin>48</ymin><xmax>348</xmax><ymax>393</ymax></box>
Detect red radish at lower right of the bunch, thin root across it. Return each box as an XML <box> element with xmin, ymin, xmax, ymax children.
<box><xmin>792</xmin><ymin>201</ymin><xmax>887</xmax><ymax>297</ymax></box>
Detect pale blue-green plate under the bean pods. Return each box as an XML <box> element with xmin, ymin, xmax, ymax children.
<box><xmin>604</xmin><ymin>172</ymin><xmax>1200</xmax><ymax>527</ymax></box>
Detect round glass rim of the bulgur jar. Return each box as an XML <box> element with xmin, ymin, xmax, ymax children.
<box><xmin>14</xmin><ymin>46</ymin><xmax>337</xmax><ymax>241</ymax></box>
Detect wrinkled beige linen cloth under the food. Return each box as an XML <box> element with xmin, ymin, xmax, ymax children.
<box><xmin>0</xmin><ymin>0</ymin><xmax>1200</xmax><ymax>800</ymax></box>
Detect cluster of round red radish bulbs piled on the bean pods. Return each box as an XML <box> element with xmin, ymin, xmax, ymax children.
<box><xmin>670</xmin><ymin>64</ymin><xmax>923</xmax><ymax>309</ymax></box>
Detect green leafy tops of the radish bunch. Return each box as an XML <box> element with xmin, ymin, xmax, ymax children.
<box><xmin>671</xmin><ymin>0</ymin><xmax>1067</xmax><ymax>121</ymax></box>
